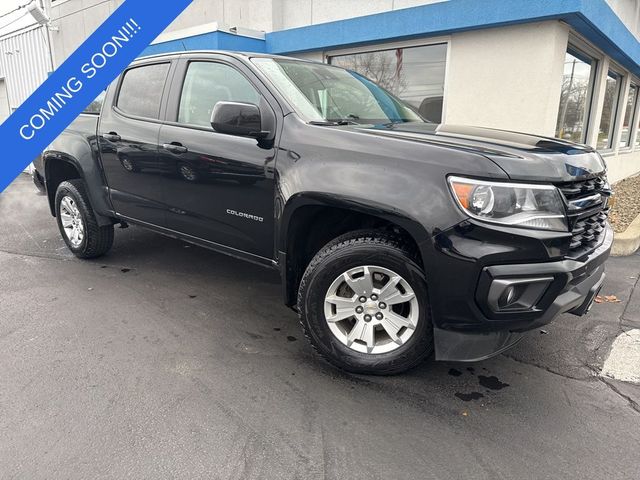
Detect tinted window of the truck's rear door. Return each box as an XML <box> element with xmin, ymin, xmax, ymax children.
<box><xmin>116</xmin><ymin>63</ymin><xmax>169</xmax><ymax>119</ymax></box>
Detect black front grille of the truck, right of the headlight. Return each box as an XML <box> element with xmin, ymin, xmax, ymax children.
<box><xmin>558</xmin><ymin>176</ymin><xmax>611</xmax><ymax>259</ymax></box>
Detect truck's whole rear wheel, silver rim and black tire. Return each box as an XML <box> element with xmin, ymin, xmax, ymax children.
<box><xmin>55</xmin><ymin>180</ymin><xmax>113</xmax><ymax>258</ymax></box>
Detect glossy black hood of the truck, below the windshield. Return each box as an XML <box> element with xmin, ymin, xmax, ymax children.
<box><xmin>348</xmin><ymin>122</ymin><xmax>606</xmax><ymax>182</ymax></box>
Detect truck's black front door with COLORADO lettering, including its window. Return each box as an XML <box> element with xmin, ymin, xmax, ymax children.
<box><xmin>159</xmin><ymin>59</ymin><xmax>275</xmax><ymax>259</ymax></box>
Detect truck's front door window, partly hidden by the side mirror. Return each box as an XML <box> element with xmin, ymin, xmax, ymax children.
<box><xmin>178</xmin><ymin>62</ymin><xmax>260</xmax><ymax>127</ymax></box>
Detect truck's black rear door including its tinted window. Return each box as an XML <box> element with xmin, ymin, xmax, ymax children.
<box><xmin>98</xmin><ymin>60</ymin><xmax>171</xmax><ymax>226</ymax></box>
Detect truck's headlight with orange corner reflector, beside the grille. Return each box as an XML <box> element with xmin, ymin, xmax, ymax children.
<box><xmin>449</xmin><ymin>177</ymin><xmax>568</xmax><ymax>232</ymax></box>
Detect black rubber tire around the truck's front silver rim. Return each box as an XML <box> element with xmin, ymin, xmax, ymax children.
<box><xmin>298</xmin><ymin>231</ymin><xmax>433</xmax><ymax>375</ymax></box>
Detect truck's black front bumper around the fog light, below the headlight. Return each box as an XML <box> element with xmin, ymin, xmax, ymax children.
<box><xmin>435</xmin><ymin>227</ymin><xmax>613</xmax><ymax>361</ymax></box>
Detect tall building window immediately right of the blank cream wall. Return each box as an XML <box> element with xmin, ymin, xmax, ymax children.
<box><xmin>556</xmin><ymin>48</ymin><xmax>597</xmax><ymax>142</ymax></box>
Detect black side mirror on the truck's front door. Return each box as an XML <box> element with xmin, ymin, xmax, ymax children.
<box><xmin>211</xmin><ymin>102</ymin><xmax>268</xmax><ymax>138</ymax></box>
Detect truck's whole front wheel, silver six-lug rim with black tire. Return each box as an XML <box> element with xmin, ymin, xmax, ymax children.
<box><xmin>298</xmin><ymin>232</ymin><xmax>433</xmax><ymax>375</ymax></box>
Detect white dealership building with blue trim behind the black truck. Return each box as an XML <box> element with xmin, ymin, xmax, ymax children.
<box><xmin>0</xmin><ymin>0</ymin><xmax>640</xmax><ymax>181</ymax></box>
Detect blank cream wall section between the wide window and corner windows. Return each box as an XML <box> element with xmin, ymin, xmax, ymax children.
<box><xmin>444</xmin><ymin>21</ymin><xmax>568</xmax><ymax>136</ymax></box>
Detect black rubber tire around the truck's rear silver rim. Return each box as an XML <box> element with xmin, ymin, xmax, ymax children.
<box><xmin>55</xmin><ymin>180</ymin><xmax>113</xmax><ymax>258</ymax></box>
